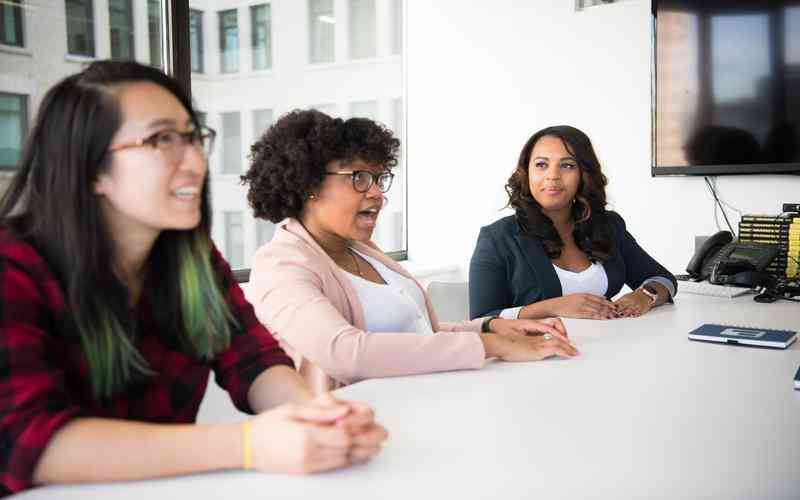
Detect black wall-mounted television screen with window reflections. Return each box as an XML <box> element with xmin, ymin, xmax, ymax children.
<box><xmin>652</xmin><ymin>0</ymin><xmax>800</xmax><ymax>175</ymax></box>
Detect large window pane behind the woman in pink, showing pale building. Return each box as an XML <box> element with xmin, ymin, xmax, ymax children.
<box><xmin>195</xmin><ymin>0</ymin><xmax>406</xmax><ymax>267</ymax></box>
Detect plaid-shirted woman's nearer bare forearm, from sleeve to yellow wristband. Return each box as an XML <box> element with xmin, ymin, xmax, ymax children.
<box><xmin>33</xmin><ymin>418</ymin><xmax>243</xmax><ymax>484</ymax></box>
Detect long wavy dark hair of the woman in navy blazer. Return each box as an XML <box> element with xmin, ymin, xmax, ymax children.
<box><xmin>506</xmin><ymin>125</ymin><xmax>612</xmax><ymax>261</ymax></box>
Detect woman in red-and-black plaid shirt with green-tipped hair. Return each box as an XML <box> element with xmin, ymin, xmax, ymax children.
<box><xmin>0</xmin><ymin>61</ymin><xmax>386</xmax><ymax>496</ymax></box>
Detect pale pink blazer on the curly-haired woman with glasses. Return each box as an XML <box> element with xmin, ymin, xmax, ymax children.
<box><xmin>247</xmin><ymin>219</ymin><xmax>485</xmax><ymax>390</ymax></box>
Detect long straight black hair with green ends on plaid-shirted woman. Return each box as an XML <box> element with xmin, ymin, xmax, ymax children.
<box><xmin>0</xmin><ymin>61</ymin><xmax>236</xmax><ymax>397</ymax></box>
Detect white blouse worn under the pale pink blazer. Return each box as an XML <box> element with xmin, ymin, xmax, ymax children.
<box><xmin>346</xmin><ymin>249</ymin><xmax>433</xmax><ymax>335</ymax></box>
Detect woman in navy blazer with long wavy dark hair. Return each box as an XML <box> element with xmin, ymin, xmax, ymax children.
<box><xmin>469</xmin><ymin>125</ymin><xmax>676</xmax><ymax>319</ymax></box>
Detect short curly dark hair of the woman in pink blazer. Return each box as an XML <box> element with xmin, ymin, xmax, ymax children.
<box><xmin>241</xmin><ymin>109</ymin><xmax>400</xmax><ymax>222</ymax></box>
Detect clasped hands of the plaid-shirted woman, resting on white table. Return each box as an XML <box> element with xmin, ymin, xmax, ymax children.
<box><xmin>252</xmin><ymin>393</ymin><xmax>388</xmax><ymax>474</ymax></box>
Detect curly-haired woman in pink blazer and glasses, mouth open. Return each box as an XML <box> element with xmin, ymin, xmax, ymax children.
<box><xmin>242</xmin><ymin>110</ymin><xmax>577</xmax><ymax>388</ymax></box>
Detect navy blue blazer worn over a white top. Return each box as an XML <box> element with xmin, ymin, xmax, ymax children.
<box><xmin>469</xmin><ymin>212</ymin><xmax>677</xmax><ymax>318</ymax></box>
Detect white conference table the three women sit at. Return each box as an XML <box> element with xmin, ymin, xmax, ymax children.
<box><xmin>15</xmin><ymin>295</ymin><xmax>800</xmax><ymax>500</ymax></box>
